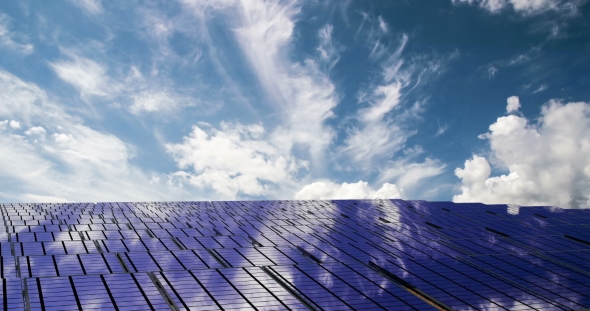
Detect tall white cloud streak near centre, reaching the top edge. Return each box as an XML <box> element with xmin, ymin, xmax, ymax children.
<box><xmin>213</xmin><ymin>0</ymin><xmax>338</xmax><ymax>158</ymax></box>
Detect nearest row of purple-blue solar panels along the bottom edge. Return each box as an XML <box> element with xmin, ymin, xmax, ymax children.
<box><xmin>9</xmin><ymin>264</ymin><xmax>434</xmax><ymax>310</ymax></box>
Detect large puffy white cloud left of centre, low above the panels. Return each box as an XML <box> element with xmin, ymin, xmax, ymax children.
<box><xmin>166</xmin><ymin>123</ymin><xmax>306</xmax><ymax>198</ymax></box>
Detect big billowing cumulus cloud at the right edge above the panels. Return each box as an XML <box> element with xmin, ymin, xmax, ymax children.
<box><xmin>453</xmin><ymin>100</ymin><xmax>590</xmax><ymax>208</ymax></box>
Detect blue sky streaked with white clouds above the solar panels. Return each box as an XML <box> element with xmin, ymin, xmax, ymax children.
<box><xmin>0</xmin><ymin>0</ymin><xmax>590</xmax><ymax>208</ymax></box>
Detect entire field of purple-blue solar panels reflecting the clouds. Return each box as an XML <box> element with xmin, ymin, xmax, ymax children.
<box><xmin>0</xmin><ymin>200</ymin><xmax>590</xmax><ymax>310</ymax></box>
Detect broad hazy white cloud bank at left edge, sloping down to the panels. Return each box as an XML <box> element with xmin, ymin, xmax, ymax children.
<box><xmin>0</xmin><ymin>70</ymin><xmax>190</xmax><ymax>201</ymax></box>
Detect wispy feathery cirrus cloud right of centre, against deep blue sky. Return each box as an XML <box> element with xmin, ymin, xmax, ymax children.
<box><xmin>330</xmin><ymin>17</ymin><xmax>458</xmax><ymax>194</ymax></box>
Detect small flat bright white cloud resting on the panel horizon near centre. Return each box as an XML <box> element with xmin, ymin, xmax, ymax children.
<box><xmin>295</xmin><ymin>180</ymin><xmax>403</xmax><ymax>200</ymax></box>
